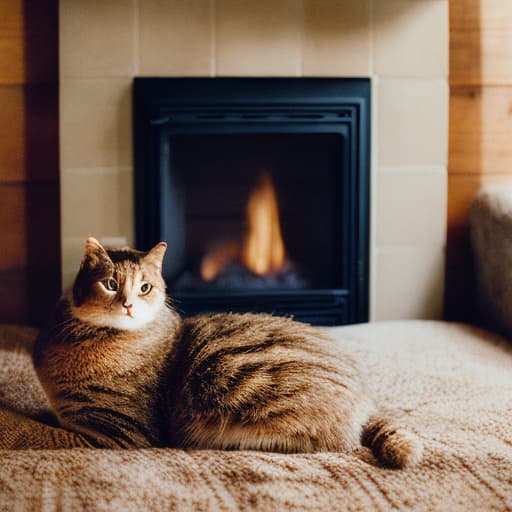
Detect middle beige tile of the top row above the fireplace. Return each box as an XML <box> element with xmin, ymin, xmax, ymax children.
<box><xmin>215</xmin><ymin>0</ymin><xmax>303</xmax><ymax>76</ymax></box>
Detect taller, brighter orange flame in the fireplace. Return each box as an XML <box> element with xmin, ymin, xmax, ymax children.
<box><xmin>242</xmin><ymin>170</ymin><xmax>286</xmax><ymax>276</ymax></box>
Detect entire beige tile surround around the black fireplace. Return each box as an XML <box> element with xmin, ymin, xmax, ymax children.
<box><xmin>60</xmin><ymin>0</ymin><xmax>448</xmax><ymax>320</ymax></box>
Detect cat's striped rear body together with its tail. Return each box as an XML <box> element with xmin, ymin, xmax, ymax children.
<box><xmin>169</xmin><ymin>314</ymin><xmax>421</xmax><ymax>467</ymax></box>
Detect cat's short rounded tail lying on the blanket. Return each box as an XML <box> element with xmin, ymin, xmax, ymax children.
<box><xmin>361</xmin><ymin>416</ymin><xmax>423</xmax><ymax>469</ymax></box>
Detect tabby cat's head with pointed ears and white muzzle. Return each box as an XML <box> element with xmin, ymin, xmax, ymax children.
<box><xmin>72</xmin><ymin>237</ymin><xmax>167</xmax><ymax>330</ymax></box>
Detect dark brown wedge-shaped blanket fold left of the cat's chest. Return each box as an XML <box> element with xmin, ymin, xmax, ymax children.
<box><xmin>0</xmin><ymin>407</ymin><xmax>114</xmax><ymax>450</ymax></box>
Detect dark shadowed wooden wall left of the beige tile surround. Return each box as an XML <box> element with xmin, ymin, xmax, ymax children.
<box><xmin>0</xmin><ymin>0</ymin><xmax>60</xmax><ymax>325</ymax></box>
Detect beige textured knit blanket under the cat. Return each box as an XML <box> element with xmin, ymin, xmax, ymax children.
<box><xmin>0</xmin><ymin>321</ymin><xmax>512</xmax><ymax>512</ymax></box>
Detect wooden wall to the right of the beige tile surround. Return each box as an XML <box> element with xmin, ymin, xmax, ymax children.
<box><xmin>445</xmin><ymin>0</ymin><xmax>512</xmax><ymax>320</ymax></box>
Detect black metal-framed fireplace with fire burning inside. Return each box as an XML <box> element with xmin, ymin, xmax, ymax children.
<box><xmin>134</xmin><ymin>78</ymin><xmax>370</xmax><ymax>325</ymax></box>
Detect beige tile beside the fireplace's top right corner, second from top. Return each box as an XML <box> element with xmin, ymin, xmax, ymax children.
<box><xmin>377</xmin><ymin>79</ymin><xmax>448</xmax><ymax>166</ymax></box>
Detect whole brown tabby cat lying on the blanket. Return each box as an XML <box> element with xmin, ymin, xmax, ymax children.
<box><xmin>33</xmin><ymin>238</ymin><xmax>422</xmax><ymax>468</ymax></box>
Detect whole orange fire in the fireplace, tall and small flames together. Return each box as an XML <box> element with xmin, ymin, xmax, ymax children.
<box><xmin>201</xmin><ymin>170</ymin><xmax>286</xmax><ymax>281</ymax></box>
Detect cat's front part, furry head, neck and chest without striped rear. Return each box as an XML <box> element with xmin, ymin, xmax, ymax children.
<box><xmin>33</xmin><ymin>239</ymin><xmax>181</xmax><ymax>448</ymax></box>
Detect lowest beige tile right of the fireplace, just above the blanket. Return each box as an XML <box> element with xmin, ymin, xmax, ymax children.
<box><xmin>373</xmin><ymin>245</ymin><xmax>445</xmax><ymax>320</ymax></box>
